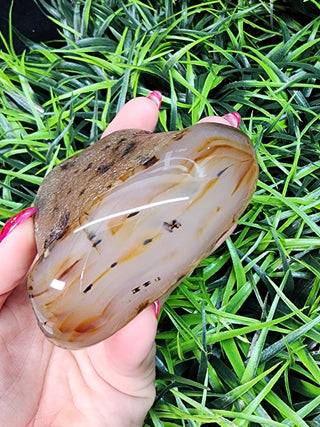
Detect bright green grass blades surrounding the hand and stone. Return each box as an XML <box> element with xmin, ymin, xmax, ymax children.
<box><xmin>0</xmin><ymin>0</ymin><xmax>320</xmax><ymax>427</ymax></box>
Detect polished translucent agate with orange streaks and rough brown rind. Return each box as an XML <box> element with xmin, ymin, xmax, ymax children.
<box><xmin>28</xmin><ymin>123</ymin><xmax>258</xmax><ymax>349</ymax></box>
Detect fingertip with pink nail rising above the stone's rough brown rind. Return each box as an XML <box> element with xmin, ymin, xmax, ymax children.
<box><xmin>102</xmin><ymin>91</ymin><xmax>161</xmax><ymax>137</ymax></box>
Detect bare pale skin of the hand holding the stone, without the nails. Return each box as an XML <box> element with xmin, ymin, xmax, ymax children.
<box><xmin>0</xmin><ymin>97</ymin><xmax>235</xmax><ymax>427</ymax></box>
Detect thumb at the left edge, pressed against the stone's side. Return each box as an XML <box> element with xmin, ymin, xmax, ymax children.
<box><xmin>0</xmin><ymin>218</ymin><xmax>37</xmax><ymax>308</ymax></box>
